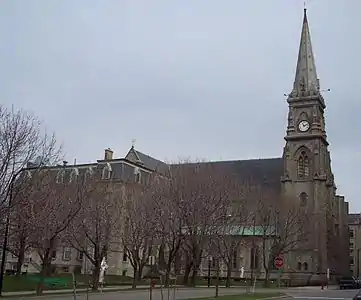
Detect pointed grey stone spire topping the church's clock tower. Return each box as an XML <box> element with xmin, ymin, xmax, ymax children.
<box><xmin>290</xmin><ymin>8</ymin><xmax>320</xmax><ymax>97</ymax></box>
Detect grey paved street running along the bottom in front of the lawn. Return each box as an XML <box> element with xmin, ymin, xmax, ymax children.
<box><xmin>7</xmin><ymin>287</ymin><xmax>357</xmax><ymax>300</ymax></box>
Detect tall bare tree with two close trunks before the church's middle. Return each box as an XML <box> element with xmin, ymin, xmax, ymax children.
<box><xmin>181</xmin><ymin>162</ymin><xmax>240</xmax><ymax>286</ymax></box>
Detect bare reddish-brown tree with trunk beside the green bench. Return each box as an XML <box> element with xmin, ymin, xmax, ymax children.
<box><xmin>22</xmin><ymin>167</ymin><xmax>86</xmax><ymax>295</ymax></box>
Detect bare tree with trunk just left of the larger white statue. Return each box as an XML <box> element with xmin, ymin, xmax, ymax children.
<box><xmin>66</xmin><ymin>178</ymin><xmax>124</xmax><ymax>290</ymax></box>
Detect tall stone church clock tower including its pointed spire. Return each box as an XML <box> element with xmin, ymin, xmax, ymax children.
<box><xmin>282</xmin><ymin>9</ymin><xmax>335</xmax><ymax>273</ymax></box>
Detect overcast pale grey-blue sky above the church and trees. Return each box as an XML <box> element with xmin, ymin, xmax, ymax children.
<box><xmin>0</xmin><ymin>0</ymin><xmax>361</xmax><ymax>211</ymax></box>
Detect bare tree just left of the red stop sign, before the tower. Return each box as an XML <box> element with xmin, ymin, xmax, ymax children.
<box><xmin>255</xmin><ymin>188</ymin><xmax>310</xmax><ymax>285</ymax></box>
